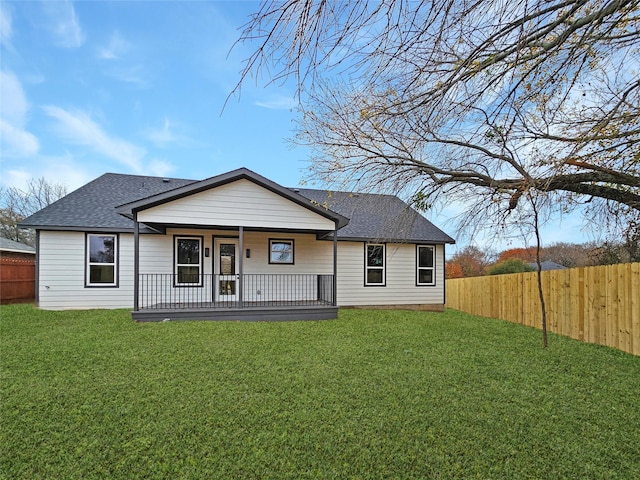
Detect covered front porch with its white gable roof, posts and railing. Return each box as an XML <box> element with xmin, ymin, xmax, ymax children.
<box><xmin>117</xmin><ymin>169</ymin><xmax>349</xmax><ymax>321</ymax></box>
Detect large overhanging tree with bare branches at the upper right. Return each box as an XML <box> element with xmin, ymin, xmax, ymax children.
<box><xmin>237</xmin><ymin>0</ymin><xmax>640</xmax><ymax>238</ymax></box>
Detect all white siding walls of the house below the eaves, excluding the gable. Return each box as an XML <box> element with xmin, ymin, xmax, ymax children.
<box><xmin>39</xmin><ymin>229</ymin><xmax>444</xmax><ymax>310</ymax></box>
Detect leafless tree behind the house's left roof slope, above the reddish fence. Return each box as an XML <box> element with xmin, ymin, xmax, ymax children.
<box><xmin>0</xmin><ymin>177</ymin><xmax>67</xmax><ymax>245</ymax></box>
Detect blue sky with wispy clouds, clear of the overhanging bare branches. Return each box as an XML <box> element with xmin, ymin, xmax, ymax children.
<box><xmin>0</xmin><ymin>1</ymin><xmax>584</xmax><ymax>251</ymax></box>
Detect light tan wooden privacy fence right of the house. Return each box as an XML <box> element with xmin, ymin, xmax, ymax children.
<box><xmin>446</xmin><ymin>263</ymin><xmax>640</xmax><ymax>355</ymax></box>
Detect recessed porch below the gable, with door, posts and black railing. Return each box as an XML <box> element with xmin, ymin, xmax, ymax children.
<box><xmin>132</xmin><ymin>222</ymin><xmax>337</xmax><ymax>321</ymax></box>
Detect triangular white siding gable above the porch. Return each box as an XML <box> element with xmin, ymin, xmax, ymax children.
<box><xmin>138</xmin><ymin>179</ymin><xmax>334</xmax><ymax>230</ymax></box>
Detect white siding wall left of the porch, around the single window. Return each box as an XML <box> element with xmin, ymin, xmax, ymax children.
<box><xmin>38</xmin><ymin>232</ymin><xmax>133</xmax><ymax>310</ymax></box>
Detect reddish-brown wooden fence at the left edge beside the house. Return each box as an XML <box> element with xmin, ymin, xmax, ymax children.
<box><xmin>0</xmin><ymin>257</ymin><xmax>36</xmax><ymax>304</ymax></box>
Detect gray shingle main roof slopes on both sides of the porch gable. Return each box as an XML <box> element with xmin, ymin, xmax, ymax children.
<box><xmin>21</xmin><ymin>173</ymin><xmax>454</xmax><ymax>243</ymax></box>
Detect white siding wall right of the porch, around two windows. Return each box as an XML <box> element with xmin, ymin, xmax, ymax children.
<box><xmin>338</xmin><ymin>242</ymin><xmax>444</xmax><ymax>306</ymax></box>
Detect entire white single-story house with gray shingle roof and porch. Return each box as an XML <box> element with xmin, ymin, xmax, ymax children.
<box><xmin>21</xmin><ymin>168</ymin><xmax>454</xmax><ymax>320</ymax></box>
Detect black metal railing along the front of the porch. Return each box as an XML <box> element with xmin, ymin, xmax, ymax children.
<box><xmin>138</xmin><ymin>273</ymin><xmax>335</xmax><ymax>310</ymax></box>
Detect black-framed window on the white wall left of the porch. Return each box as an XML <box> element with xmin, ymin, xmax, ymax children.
<box><xmin>85</xmin><ymin>233</ymin><xmax>118</xmax><ymax>287</ymax></box>
